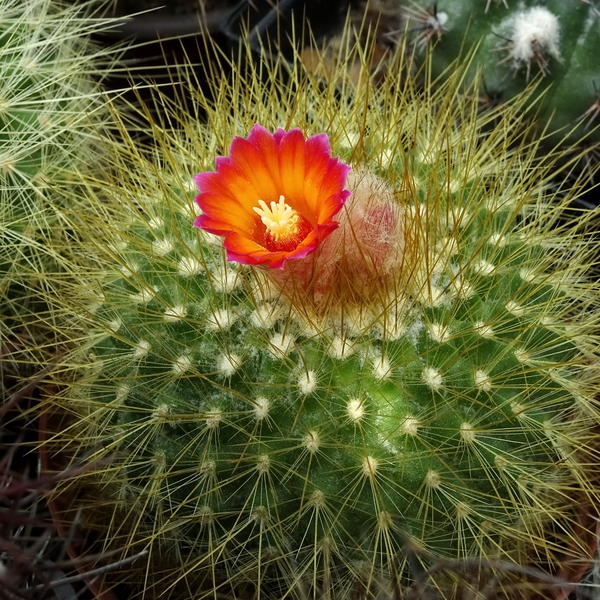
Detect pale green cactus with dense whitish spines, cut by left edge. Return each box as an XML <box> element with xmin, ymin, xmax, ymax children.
<box><xmin>0</xmin><ymin>0</ymin><xmax>120</xmax><ymax>376</ymax></box>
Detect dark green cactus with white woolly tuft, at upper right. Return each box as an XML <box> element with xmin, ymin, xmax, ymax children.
<box><xmin>404</xmin><ymin>0</ymin><xmax>600</xmax><ymax>157</ymax></box>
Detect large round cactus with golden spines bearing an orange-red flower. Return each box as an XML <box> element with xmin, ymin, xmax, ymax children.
<box><xmin>37</xmin><ymin>25</ymin><xmax>600</xmax><ymax>598</ymax></box>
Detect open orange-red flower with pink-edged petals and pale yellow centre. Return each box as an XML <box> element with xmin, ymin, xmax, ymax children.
<box><xmin>194</xmin><ymin>124</ymin><xmax>350</xmax><ymax>269</ymax></box>
